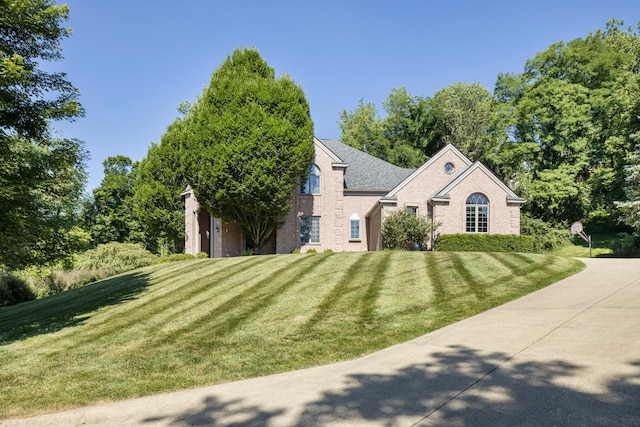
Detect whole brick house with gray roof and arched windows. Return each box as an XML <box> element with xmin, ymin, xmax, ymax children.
<box><xmin>182</xmin><ymin>139</ymin><xmax>524</xmax><ymax>258</ymax></box>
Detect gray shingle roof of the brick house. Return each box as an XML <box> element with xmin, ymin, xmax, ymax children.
<box><xmin>320</xmin><ymin>139</ymin><xmax>415</xmax><ymax>193</ymax></box>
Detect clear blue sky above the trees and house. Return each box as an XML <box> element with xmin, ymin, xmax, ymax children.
<box><xmin>52</xmin><ymin>0</ymin><xmax>640</xmax><ymax>191</ymax></box>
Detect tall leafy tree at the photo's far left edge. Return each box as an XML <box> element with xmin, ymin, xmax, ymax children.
<box><xmin>0</xmin><ymin>0</ymin><xmax>87</xmax><ymax>266</ymax></box>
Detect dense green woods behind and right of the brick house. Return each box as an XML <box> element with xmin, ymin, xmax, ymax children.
<box><xmin>339</xmin><ymin>20</ymin><xmax>640</xmax><ymax>228</ymax></box>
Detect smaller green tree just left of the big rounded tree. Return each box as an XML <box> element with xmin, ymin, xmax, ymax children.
<box><xmin>133</xmin><ymin>144</ymin><xmax>186</xmax><ymax>255</ymax></box>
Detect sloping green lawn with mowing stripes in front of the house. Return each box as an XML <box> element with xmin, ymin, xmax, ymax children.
<box><xmin>0</xmin><ymin>251</ymin><xmax>584</xmax><ymax>419</ymax></box>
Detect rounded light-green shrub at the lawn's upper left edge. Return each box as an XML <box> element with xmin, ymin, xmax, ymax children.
<box><xmin>76</xmin><ymin>242</ymin><xmax>157</xmax><ymax>275</ymax></box>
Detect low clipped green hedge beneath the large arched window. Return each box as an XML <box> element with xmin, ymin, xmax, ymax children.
<box><xmin>434</xmin><ymin>234</ymin><xmax>533</xmax><ymax>252</ymax></box>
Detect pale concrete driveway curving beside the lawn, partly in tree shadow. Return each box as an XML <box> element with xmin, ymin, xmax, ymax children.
<box><xmin>0</xmin><ymin>259</ymin><xmax>640</xmax><ymax>427</ymax></box>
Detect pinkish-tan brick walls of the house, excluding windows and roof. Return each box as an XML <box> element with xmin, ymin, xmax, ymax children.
<box><xmin>183</xmin><ymin>139</ymin><xmax>524</xmax><ymax>257</ymax></box>
